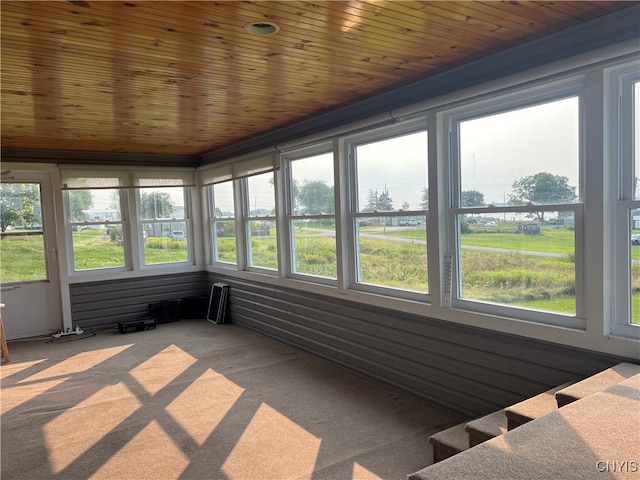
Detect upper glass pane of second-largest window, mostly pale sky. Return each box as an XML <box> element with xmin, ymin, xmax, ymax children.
<box><xmin>356</xmin><ymin>132</ymin><xmax>428</xmax><ymax>212</ymax></box>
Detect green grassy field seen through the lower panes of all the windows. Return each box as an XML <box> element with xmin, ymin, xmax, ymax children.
<box><xmin>0</xmin><ymin>227</ymin><xmax>640</xmax><ymax>323</ymax></box>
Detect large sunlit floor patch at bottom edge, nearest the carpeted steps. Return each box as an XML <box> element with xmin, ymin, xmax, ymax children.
<box><xmin>222</xmin><ymin>403</ymin><xmax>322</xmax><ymax>480</ymax></box>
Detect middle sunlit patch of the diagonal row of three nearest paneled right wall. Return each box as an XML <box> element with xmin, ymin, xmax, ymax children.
<box><xmin>166</xmin><ymin>369</ymin><xmax>244</xmax><ymax>445</ymax></box>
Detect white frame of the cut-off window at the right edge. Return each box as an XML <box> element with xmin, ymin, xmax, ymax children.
<box><xmin>605</xmin><ymin>62</ymin><xmax>640</xmax><ymax>339</ymax></box>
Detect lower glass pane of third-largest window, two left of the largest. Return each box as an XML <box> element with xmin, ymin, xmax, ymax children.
<box><xmin>291</xmin><ymin>218</ymin><xmax>337</xmax><ymax>278</ymax></box>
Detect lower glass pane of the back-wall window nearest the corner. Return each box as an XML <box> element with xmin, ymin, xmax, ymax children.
<box><xmin>142</xmin><ymin>221</ymin><xmax>189</xmax><ymax>265</ymax></box>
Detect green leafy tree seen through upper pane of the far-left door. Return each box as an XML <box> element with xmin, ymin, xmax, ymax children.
<box><xmin>0</xmin><ymin>183</ymin><xmax>42</xmax><ymax>232</ymax></box>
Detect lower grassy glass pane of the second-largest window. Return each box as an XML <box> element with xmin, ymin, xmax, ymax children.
<box><xmin>356</xmin><ymin>215</ymin><xmax>428</xmax><ymax>293</ymax></box>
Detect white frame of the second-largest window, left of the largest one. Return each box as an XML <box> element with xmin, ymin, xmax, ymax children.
<box><xmin>342</xmin><ymin>119</ymin><xmax>435</xmax><ymax>303</ymax></box>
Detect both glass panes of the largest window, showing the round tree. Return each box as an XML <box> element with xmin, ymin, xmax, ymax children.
<box><xmin>452</xmin><ymin>95</ymin><xmax>582</xmax><ymax>316</ymax></box>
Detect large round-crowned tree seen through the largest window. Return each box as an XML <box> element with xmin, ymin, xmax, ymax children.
<box><xmin>511</xmin><ymin>172</ymin><xmax>576</xmax><ymax>221</ymax></box>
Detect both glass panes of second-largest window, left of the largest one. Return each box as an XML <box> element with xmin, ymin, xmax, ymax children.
<box><xmin>350</xmin><ymin>125</ymin><xmax>429</xmax><ymax>296</ymax></box>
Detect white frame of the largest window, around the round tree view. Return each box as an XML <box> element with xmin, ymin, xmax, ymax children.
<box><xmin>440</xmin><ymin>75</ymin><xmax>587</xmax><ymax>330</ymax></box>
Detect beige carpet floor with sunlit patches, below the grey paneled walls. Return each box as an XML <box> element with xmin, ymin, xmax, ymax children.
<box><xmin>0</xmin><ymin>320</ymin><xmax>465</xmax><ymax>480</ymax></box>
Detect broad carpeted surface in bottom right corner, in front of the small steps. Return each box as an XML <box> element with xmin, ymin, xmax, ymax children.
<box><xmin>407</xmin><ymin>375</ymin><xmax>640</xmax><ymax>480</ymax></box>
